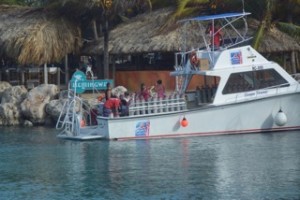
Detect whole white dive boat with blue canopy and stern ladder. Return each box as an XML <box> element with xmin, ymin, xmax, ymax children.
<box><xmin>57</xmin><ymin>12</ymin><xmax>300</xmax><ymax>140</ymax></box>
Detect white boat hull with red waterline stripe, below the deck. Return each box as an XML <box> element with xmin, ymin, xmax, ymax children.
<box><xmin>97</xmin><ymin>93</ymin><xmax>300</xmax><ymax>139</ymax></box>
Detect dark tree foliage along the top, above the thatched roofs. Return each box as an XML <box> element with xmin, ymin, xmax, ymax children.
<box><xmin>0</xmin><ymin>0</ymin><xmax>300</xmax><ymax>71</ymax></box>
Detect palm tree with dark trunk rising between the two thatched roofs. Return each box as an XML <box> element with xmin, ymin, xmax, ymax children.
<box><xmin>25</xmin><ymin>0</ymin><xmax>152</xmax><ymax>79</ymax></box>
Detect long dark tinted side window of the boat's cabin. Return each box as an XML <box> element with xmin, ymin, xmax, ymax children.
<box><xmin>223</xmin><ymin>69</ymin><xmax>289</xmax><ymax>94</ymax></box>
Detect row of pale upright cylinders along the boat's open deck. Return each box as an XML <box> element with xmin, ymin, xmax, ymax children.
<box><xmin>129</xmin><ymin>94</ymin><xmax>187</xmax><ymax>116</ymax></box>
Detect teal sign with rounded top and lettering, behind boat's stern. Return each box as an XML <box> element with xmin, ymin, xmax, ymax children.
<box><xmin>70</xmin><ymin>70</ymin><xmax>113</xmax><ymax>94</ymax></box>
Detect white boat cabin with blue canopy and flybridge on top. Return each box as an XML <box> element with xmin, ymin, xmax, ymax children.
<box><xmin>171</xmin><ymin>13</ymin><xmax>297</xmax><ymax>106</ymax></box>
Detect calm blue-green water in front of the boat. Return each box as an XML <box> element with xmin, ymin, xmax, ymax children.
<box><xmin>0</xmin><ymin>127</ymin><xmax>300</xmax><ymax>200</ymax></box>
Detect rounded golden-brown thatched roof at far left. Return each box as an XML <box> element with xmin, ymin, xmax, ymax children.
<box><xmin>0</xmin><ymin>5</ymin><xmax>81</xmax><ymax>65</ymax></box>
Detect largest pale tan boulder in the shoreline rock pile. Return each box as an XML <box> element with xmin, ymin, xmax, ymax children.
<box><xmin>21</xmin><ymin>84</ymin><xmax>58</xmax><ymax>124</ymax></box>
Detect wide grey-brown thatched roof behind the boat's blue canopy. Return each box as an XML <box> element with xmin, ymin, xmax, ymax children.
<box><xmin>83</xmin><ymin>9</ymin><xmax>300</xmax><ymax>55</ymax></box>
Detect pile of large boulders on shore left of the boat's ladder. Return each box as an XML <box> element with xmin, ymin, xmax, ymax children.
<box><xmin>0</xmin><ymin>81</ymin><xmax>67</xmax><ymax>126</ymax></box>
